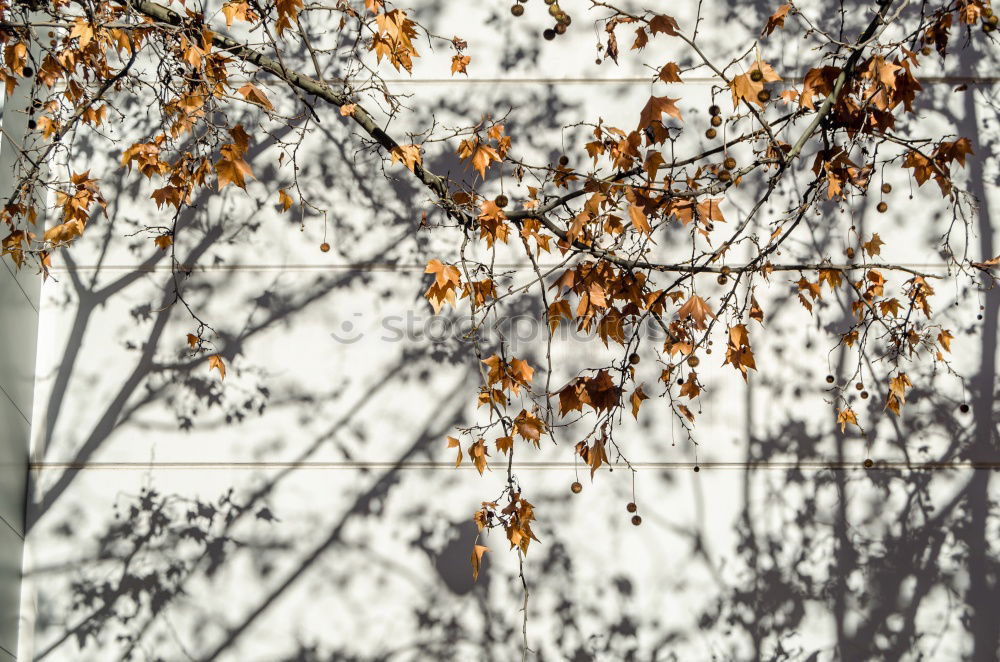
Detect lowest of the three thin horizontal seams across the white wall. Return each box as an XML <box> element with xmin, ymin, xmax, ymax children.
<box><xmin>28</xmin><ymin>460</ymin><xmax>1000</xmax><ymax>471</ymax></box>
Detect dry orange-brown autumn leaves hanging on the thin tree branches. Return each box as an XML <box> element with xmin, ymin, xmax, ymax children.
<box><xmin>0</xmin><ymin>0</ymin><xmax>997</xmax><ymax>616</ymax></box>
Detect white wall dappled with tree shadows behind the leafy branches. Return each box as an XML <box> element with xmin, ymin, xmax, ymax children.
<box><xmin>9</xmin><ymin>0</ymin><xmax>1000</xmax><ymax>662</ymax></box>
